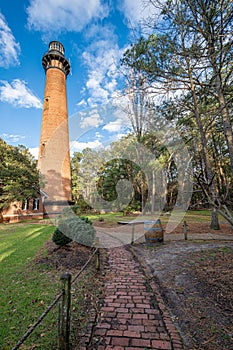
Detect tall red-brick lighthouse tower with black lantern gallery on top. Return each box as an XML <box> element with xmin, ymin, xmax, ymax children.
<box><xmin>38</xmin><ymin>41</ymin><xmax>71</xmax><ymax>214</ymax></box>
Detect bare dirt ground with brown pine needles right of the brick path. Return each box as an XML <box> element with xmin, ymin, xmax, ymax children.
<box><xmin>134</xmin><ymin>241</ymin><xmax>233</xmax><ymax>350</ymax></box>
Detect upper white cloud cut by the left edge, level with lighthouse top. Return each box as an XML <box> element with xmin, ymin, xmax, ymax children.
<box><xmin>0</xmin><ymin>13</ymin><xmax>20</xmax><ymax>68</ymax></box>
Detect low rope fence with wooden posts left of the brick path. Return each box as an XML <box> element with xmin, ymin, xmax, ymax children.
<box><xmin>11</xmin><ymin>246</ymin><xmax>100</xmax><ymax>350</ymax></box>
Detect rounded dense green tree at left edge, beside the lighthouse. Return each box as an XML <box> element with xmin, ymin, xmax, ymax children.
<box><xmin>0</xmin><ymin>139</ymin><xmax>40</xmax><ymax>217</ymax></box>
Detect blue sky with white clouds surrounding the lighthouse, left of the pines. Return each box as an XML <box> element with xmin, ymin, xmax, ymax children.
<box><xmin>0</xmin><ymin>0</ymin><xmax>156</xmax><ymax>159</ymax></box>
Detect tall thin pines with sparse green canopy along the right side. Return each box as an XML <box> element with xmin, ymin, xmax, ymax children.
<box><xmin>122</xmin><ymin>0</ymin><xmax>233</xmax><ymax>228</ymax></box>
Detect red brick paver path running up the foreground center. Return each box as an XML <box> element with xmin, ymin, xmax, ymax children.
<box><xmin>82</xmin><ymin>246</ymin><xmax>183</xmax><ymax>350</ymax></box>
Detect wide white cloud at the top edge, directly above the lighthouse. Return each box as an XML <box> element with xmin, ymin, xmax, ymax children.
<box><xmin>27</xmin><ymin>0</ymin><xmax>108</xmax><ymax>33</ymax></box>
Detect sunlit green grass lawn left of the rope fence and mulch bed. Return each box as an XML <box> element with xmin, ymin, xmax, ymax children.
<box><xmin>0</xmin><ymin>224</ymin><xmax>58</xmax><ymax>350</ymax></box>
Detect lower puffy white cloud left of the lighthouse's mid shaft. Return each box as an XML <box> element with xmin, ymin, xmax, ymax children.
<box><xmin>0</xmin><ymin>79</ymin><xmax>42</xmax><ymax>108</ymax></box>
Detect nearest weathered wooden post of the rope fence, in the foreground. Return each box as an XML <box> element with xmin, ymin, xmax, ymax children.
<box><xmin>58</xmin><ymin>272</ymin><xmax>71</xmax><ymax>350</ymax></box>
